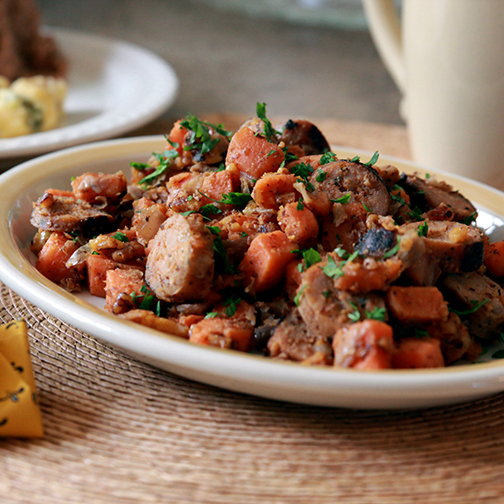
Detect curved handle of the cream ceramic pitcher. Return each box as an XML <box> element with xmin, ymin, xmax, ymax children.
<box><xmin>364</xmin><ymin>0</ymin><xmax>406</xmax><ymax>95</ymax></box>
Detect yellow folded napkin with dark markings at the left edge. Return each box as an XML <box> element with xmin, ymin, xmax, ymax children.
<box><xmin>0</xmin><ymin>320</ymin><xmax>44</xmax><ymax>437</ymax></box>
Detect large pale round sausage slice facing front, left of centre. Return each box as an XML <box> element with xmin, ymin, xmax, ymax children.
<box><xmin>145</xmin><ymin>214</ymin><xmax>215</xmax><ymax>302</ymax></box>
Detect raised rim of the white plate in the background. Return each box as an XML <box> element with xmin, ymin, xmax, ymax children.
<box><xmin>0</xmin><ymin>26</ymin><xmax>180</xmax><ymax>160</ymax></box>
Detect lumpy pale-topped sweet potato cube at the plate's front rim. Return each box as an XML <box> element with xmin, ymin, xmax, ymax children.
<box><xmin>333</xmin><ymin>319</ymin><xmax>395</xmax><ymax>370</ymax></box>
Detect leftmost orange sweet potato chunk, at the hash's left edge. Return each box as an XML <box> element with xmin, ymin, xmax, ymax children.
<box><xmin>35</xmin><ymin>231</ymin><xmax>84</xmax><ymax>284</ymax></box>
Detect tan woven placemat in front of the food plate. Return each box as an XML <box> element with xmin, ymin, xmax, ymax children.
<box><xmin>0</xmin><ymin>284</ymin><xmax>504</xmax><ymax>504</ymax></box>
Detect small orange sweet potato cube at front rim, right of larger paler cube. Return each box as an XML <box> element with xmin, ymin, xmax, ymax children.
<box><xmin>392</xmin><ymin>338</ymin><xmax>445</xmax><ymax>369</ymax></box>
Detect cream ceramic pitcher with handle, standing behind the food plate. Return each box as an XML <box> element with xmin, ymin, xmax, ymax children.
<box><xmin>364</xmin><ymin>0</ymin><xmax>504</xmax><ymax>183</ymax></box>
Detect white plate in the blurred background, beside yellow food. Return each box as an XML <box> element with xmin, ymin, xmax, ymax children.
<box><xmin>0</xmin><ymin>28</ymin><xmax>179</xmax><ymax>159</ymax></box>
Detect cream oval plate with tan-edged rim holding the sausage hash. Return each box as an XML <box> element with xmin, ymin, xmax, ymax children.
<box><xmin>0</xmin><ymin>136</ymin><xmax>504</xmax><ymax>409</ymax></box>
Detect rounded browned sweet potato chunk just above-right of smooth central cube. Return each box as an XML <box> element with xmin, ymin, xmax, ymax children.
<box><xmin>278</xmin><ymin>203</ymin><xmax>319</xmax><ymax>247</ymax></box>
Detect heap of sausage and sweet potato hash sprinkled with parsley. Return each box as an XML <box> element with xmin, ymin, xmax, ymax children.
<box><xmin>31</xmin><ymin>104</ymin><xmax>504</xmax><ymax>370</ymax></box>
